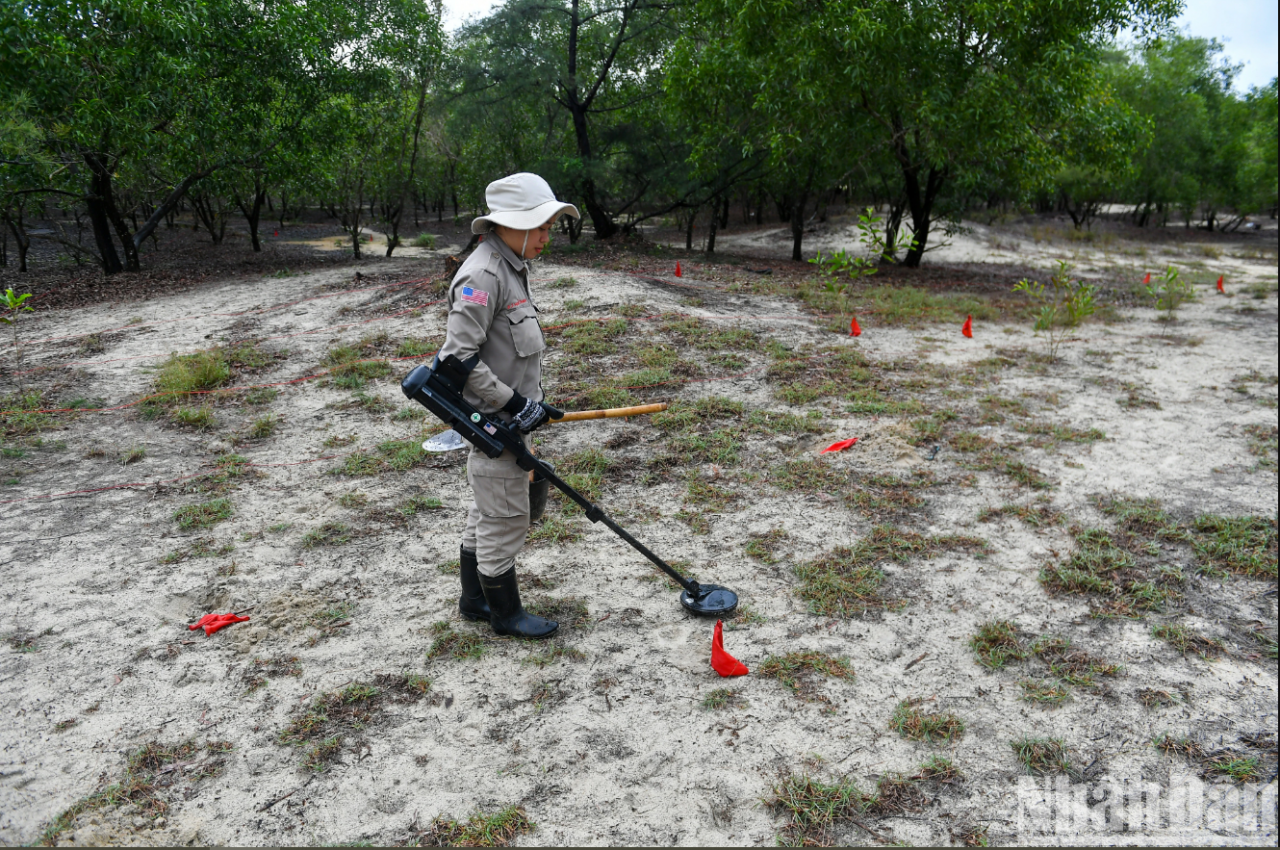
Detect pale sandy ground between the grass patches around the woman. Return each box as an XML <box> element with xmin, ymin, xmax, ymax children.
<box><xmin>0</xmin><ymin>218</ymin><xmax>1277</xmax><ymax>846</ymax></box>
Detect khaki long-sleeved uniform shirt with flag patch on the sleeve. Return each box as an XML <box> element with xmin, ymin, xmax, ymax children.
<box><xmin>440</xmin><ymin>233</ymin><xmax>547</xmax><ymax>419</ymax></box>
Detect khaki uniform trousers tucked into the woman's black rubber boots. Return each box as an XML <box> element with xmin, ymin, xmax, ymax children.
<box><xmin>462</xmin><ymin>434</ymin><xmax>529</xmax><ymax>576</ymax></box>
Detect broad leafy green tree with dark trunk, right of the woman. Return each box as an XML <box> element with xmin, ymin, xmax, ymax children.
<box><xmin>686</xmin><ymin>0</ymin><xmax>1180</xmax><ymax>266</ymax></box>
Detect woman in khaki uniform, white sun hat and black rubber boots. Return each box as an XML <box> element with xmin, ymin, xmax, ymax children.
<box><xmin>439</xmin><ymin>173</ymin><xmax>580</xmax><ymax>638</ymax></box>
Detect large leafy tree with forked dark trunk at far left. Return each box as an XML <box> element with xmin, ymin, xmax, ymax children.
<box><xmin>0</xmin><ymin>0</ymin><xmax>432</xmax><ymax>274</ymax></box>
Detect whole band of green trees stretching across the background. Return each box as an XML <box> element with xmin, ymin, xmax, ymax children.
<box><xmin>0</xmin><ymin>0</ymin><xmax>1277</xmax><ymax>274</ymax></box>
